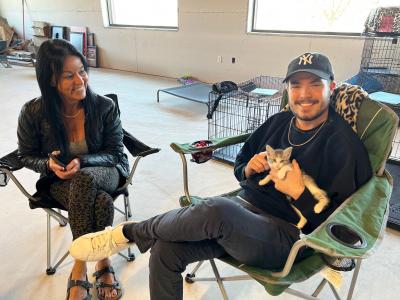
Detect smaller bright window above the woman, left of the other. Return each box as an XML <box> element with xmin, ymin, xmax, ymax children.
<box><xmin>106</xmin><ymin>0</ymin><xmax>178</xmax><ymax>29</ymax></box>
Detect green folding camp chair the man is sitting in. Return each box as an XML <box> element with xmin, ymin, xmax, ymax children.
<box><xmin>171</xmin><ymin>85</ymin><xmax>399</xmax><ymax>299</ymax></box>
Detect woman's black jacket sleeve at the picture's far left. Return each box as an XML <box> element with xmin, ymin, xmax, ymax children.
<box><xmin>17</xmin><ymin>101</ymin><xmax>48</xmax><ymax>174</ymax></box>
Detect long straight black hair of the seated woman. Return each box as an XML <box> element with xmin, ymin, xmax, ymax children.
<box><xmin>36</xmin><ymin>39</ymin><xmax>96</xmax><ymax>156</ymax></box>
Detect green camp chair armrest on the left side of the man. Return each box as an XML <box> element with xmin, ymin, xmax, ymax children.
<box><xmin>170</xmin><ymin>133</ymin><xmax>250</xmax><ymax>154</ymax></box>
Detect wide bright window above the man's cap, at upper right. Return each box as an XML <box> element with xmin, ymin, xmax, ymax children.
<box><xmin>249</xmin><ymin>0</ymin><xmax>399</xmax><ymax>35</ymax></box>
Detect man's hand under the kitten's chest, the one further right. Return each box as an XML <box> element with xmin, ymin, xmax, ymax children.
<box><xmin>269</xmin><ymin>159</ymin><xmax>305</xmax><ymax>200</ymax></box>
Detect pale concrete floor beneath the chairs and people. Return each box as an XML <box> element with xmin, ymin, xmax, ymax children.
<box><xmin>0</xmin><ymin>67</ymin><xmax>400</xmax><ymax>300</ymax></box>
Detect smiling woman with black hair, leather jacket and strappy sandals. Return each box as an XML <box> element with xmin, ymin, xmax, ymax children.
<box><xmin>17</xmin><ymin>39</ymin><xmax>129</xmax><ymax>300</ymax></box>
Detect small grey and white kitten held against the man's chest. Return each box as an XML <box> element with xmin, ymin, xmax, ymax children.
<box><xmin>258</xmin><ymin>145</ymin><xmax>329</xmax><ymax>229</ymax></box>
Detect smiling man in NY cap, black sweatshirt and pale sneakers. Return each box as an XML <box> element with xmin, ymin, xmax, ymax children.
<box><xmin>70</xmin><ymin>53</ymin><xmax>372</xmax><ymax>299</ymax></box>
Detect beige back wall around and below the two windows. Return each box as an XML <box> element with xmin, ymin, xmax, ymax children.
<box><xmin>0</xmin><ymin>0</ymin><xmax>363</xmax><ymax>82</ymax></box>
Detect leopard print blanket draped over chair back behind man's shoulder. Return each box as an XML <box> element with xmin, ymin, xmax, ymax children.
<box><xmin>282</xmin><ymin>83</ymin><xmax>368</xmax><ymax>133</ymax></box>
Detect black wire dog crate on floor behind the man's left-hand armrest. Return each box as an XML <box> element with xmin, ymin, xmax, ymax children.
<box><xmin>208</xmin><ymin>76</ymin><xmax>284</xmax><ymax>163</ymax></box>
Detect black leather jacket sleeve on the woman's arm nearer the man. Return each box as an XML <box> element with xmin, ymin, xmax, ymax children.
<box><xmin>78</xmin><ymin>100</ymin><xmax>124</xmax><ymax>167</ymax></box>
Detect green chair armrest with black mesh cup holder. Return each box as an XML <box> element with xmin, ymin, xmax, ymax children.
<box><xmin>302</xmin><ymin>173</ymin><xmax>393</xmax><ymax>258</ymax></box>
